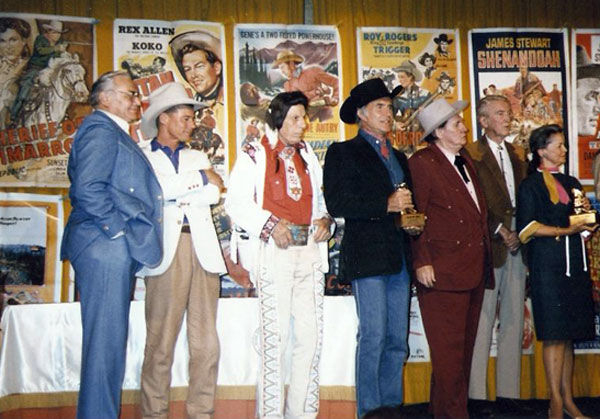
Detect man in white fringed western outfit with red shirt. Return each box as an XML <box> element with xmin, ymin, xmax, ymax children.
<box><xmin>225</xmin><ymin>92</ymin><xmax>333</xmax><ymax>418</ymax></box>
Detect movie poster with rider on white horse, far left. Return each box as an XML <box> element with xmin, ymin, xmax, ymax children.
<box><xmin>0</xmin><ymin>13</ymin><xmax>96</xmax><ymax>187</ymax></box>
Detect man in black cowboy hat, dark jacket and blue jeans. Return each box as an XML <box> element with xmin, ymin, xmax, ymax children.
<box><xmin>323</xmin><ymin>78</ymin><xmax>413</xmax><ymax>417</ymax></box>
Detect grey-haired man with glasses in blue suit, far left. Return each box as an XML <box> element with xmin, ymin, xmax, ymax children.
<box><xmin>61</xmin><ymin>71</ymin><xmax>163</xmax><ymax>419</ymax></box>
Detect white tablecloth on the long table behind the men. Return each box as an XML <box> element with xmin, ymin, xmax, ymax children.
<box><xmin>0</xmin><ymin>297</ymin><xmax>357</xmax><ymax>397</ymax></box>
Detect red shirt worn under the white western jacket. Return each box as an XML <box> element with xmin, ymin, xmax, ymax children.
<box><xmin>261</xmin><ymin>136</ymin><xmax>313</xmax><ymax>224</ymax></box>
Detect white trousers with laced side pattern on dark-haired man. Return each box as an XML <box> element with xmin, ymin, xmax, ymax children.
<box><xmin>254</xmin><ymin>237</ymin><xmax>324</xmax><ymax>419</ymax></box>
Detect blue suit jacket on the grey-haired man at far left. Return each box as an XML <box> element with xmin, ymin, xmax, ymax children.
<box><xmin>61</xmin><ymin>111</ymin><xmax>163</xmax><ymax>269</ymax></box>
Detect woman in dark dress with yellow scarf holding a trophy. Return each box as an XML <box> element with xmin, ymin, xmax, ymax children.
<box><xmin>517</xmin><ymin>125</ymin><xmax>597</xmax><ymax>418</ymax></box>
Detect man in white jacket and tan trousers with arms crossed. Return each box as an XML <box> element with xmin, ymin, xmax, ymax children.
<box><xmin>141</xmin><ymin>83</ymin><xmax>226</xmax><ymax>418</ymax></box>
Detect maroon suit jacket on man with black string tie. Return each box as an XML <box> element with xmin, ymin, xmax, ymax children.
<box><xmin>408</xmin><ymin>144</ymin><xmax>494</xmax><ymax>291</ymax></box>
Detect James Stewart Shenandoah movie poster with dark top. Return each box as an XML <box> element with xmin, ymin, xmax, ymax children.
<box><xmin>469</xmin><ymin>28</ymin><xmax>570</xmax><ymax>155</ymax></box>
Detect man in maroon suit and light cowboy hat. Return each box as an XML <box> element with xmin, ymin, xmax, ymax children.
<box><xmin>408</xmin><ymin>99</ymin><xmax>493</xmax><ymax>418</ymax></box>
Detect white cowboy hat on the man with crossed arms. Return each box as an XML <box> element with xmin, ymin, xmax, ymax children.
<box><xmin>141</xmin><ymin>82</ymin><xmax>207</xmax><ymax>138</ymax></box>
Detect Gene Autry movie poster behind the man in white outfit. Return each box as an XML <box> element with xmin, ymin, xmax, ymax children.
<box><xmin>234</xmin><ymin>24</ymin><xmax>343</xmax><ymax>162</ymax></box>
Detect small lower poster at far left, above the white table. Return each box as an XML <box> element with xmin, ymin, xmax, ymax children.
<box><xmin>0</xmin><ymin>192</ymin><xmax>64</xmax><ymax>305</ymax></box>
